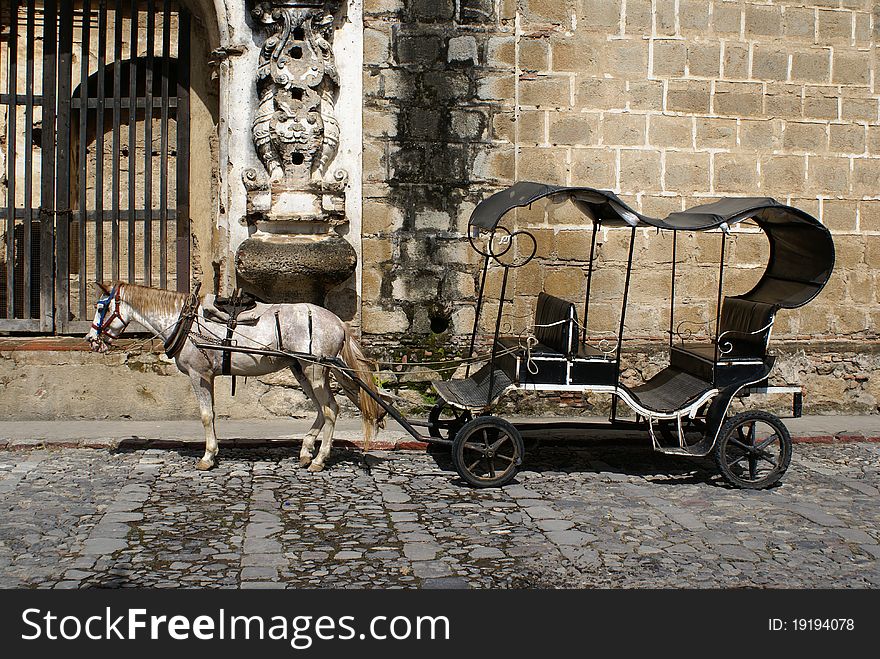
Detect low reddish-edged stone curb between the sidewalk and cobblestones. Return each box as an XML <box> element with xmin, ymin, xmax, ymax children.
<box><xmin>0</xmin><ymin>434</ymin><xmax>880</xmax><ymax>451</ymax></box>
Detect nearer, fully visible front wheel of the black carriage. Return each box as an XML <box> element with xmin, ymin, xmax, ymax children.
<box><xmin>452</xmin><ymin>416</ymin><xmax>525</xmax><ymax>487</ymax></box>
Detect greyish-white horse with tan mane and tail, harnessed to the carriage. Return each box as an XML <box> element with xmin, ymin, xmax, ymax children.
<box><xmin>86</xmin><ymin>282</ymin><xmax>385</xmax><ymax>471</ymax></box>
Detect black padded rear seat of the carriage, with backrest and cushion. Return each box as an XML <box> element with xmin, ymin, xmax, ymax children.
<box><xmin>670</xmin><ymin>297</ymin><xmax>776</xmax><ymax>377</ymax></box>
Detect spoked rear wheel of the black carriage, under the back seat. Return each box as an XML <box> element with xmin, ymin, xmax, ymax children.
<box><xmin>715</xmin><ymin>412</ymin><xmax>791</xmax><ymax>490</ymax></box>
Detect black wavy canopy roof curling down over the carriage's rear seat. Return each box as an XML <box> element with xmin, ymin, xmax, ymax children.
<box><xmin>470</xmin><ymin>181</ymin><xmax>834</xmax><ymax>309</ymax></box>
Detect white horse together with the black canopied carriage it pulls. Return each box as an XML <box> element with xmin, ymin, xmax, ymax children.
<box><xmin>89</xmin><ymin>182</ymin><xmax>834</xmax><ymax>488</ymax></box>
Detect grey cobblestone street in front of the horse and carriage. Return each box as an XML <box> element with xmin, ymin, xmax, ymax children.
<box><xmin>0</xmin><ymin>442</ymin><xmax>880</xmax><ymax>588</ymax></box>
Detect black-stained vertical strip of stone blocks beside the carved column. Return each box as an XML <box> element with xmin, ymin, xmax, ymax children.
<box><xmin>382</xmin><ymin>0</ymin><xmax>495</xmax><ymax>334</ymax></box>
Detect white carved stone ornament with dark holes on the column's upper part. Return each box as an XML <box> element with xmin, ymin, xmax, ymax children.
<box><xmin>251</xmin><ymin>0</ymin><xmax>345</xmax><ymax>189</ymax></box>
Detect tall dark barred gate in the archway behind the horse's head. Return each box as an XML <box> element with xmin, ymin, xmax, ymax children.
<box><xmin>0</xmin><ymin>0</ymin><xmax>190</xmax><ymax>333</ymax></box>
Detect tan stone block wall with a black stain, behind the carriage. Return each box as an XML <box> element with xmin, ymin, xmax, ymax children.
<box><xmin>362</xmin><ymin>0</ymin><xmax>880</xmax><ymax>411</ymax></box>
